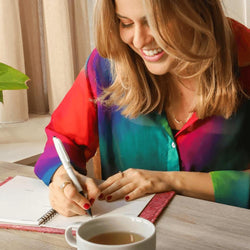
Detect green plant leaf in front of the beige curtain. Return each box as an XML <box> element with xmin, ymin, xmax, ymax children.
<box><xmin>0</xmin><ymin>63</ymin><xmax>29</xmax><ymax>91</ymax></box>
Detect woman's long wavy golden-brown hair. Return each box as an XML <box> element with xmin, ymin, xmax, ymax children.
<box><xmin>94</xmin><ymin>0</ymin><xmax>240</xmax><ymax>118</ymax></box>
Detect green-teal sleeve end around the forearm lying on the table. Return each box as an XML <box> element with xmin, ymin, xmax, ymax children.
<box><xmin>210</xmin><ymin>170</ymin><xmax>250</xmax><ymax>208</ymax></box>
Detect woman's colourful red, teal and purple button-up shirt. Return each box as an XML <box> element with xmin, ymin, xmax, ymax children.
<box><xmin>35</xmin><ymin>18</ymin><xmax>250</xmax><ymax>208</ymax></box>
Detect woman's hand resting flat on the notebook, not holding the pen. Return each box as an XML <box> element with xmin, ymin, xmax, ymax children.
<box><xmin>99</xmin><ymin>168</ymin><xmax>171</xmax><ymax>201</ymax></box>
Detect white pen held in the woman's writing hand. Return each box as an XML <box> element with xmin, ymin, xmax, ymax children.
<box><xmin>53</xmin><ymin>136</ymin><xmax>92</xmax><ymax>217</ymax></box>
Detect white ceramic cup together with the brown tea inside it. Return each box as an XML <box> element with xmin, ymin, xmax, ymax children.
<box><xmin>65</xmin><ymin>215</ymin><xmax>156</xmax><ymax>250</ymax></box>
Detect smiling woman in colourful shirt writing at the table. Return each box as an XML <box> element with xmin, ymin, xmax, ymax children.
<box><xmin>35</xmin><ymin>0</ymin><xmax>250</xmax><ymax>216</ymax></box>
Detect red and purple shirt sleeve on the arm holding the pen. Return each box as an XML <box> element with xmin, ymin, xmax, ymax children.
<box><xmin>34</xmin><ymin>62</ymin><xmax>98</xmax><ymax>185</ymax></box>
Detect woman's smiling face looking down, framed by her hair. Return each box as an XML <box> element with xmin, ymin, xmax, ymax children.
<box><xmin>115</xmin><ymin>0</ymin><xmax>174</xmax><ymax>75</ymax></box>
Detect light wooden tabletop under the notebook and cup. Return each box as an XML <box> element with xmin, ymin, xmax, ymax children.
<box><xmin>0</xmin><ymin>162</ymin><xmax>250</xmax><ymax>250</ymax></box>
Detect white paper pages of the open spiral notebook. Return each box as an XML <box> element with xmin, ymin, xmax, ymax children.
<box><xmin>0</xmin><ymin>176</ymin><xmax>153</xmax><ymax>229</ymax></box>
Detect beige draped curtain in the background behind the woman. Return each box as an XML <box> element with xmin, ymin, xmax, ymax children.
<box><xmin>0</xmin><ymin>0</ymin><xmax>95</xmax><ymax>117</ymax></box>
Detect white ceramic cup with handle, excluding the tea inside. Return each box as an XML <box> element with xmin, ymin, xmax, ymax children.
<box><xmin>65</xmin><ymin>215</ymin><xmax>156</xmax><ymax>250</ymax></box>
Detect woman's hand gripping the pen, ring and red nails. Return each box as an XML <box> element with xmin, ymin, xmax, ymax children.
<box><xmin>49</xmin><ymin>166</ymin><xmax>100</xmax><ymax>216</ymax></box>
